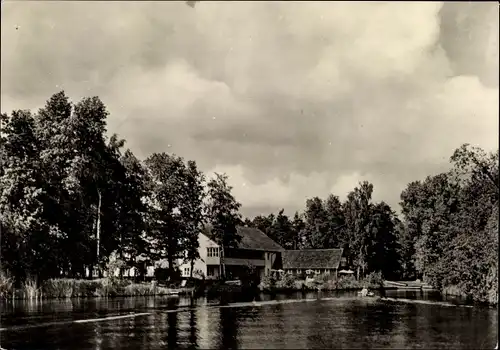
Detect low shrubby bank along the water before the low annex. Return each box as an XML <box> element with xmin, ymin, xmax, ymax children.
<box><xmin>259</xmin><ymin>274</ymin><xmax>383</xmax><ymax>292</ymax></box>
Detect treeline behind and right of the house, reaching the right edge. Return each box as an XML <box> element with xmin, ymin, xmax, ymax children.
<box><xmin>245</xmin><ymin>144</ymin><xmax>499</xmax><ymax>303</ymax></box>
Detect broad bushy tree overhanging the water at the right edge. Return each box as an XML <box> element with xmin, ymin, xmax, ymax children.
<box><xmin>401</xmin><ymin>144</ymin><xmax>499</xmax><ymax>302</ymax></box>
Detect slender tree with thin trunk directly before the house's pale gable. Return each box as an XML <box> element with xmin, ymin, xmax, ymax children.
<box><xmin>205</xmin><ymin>173</ymin><xmax>241</xmax><ymax>278</ymax></box>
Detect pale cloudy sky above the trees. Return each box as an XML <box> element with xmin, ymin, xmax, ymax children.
<box><xmin>1</xmin><ymin>0</ymin><xmax>499</xmax><ymax>216</ymax></box>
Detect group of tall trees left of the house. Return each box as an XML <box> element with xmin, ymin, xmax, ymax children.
<box><xmin>0</xmin><ymin>92</ymin><xmax>240</xmax><ymax>282</ymax></box>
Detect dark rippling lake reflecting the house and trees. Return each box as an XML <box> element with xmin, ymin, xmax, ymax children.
<box><xmin>0</xmin><ymin>291</ymin><xmax>498</xmax><ymax>350</ymax></box>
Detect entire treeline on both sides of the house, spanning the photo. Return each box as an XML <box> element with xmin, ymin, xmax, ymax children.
<box><xmin>0</xmin><ymin>92</ymin><xmax>499</xmax><ymax>302</ymax></box>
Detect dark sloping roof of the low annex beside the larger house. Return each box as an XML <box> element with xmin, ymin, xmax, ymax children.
<box><xmin>282</xmin><ymin>249</ymin><xmax>343</xmax><ymax>269</ymax></box>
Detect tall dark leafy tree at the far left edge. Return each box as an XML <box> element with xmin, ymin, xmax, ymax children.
<box><xmin>0</xmin><ymin>110</ymin><xmax>57</xmax><ymax>282</ymax></box>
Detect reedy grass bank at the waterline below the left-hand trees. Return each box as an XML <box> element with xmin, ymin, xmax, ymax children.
<box><xmin>0</xmin><ymin>278</ymin><xmax>192</xmax><ymax>299</ymax></box>
